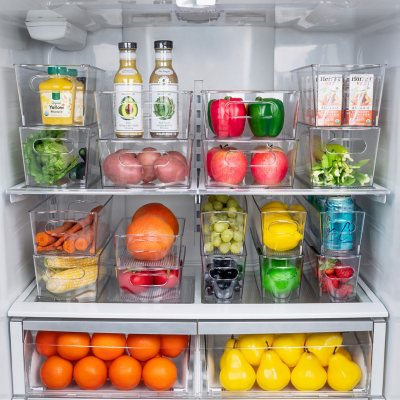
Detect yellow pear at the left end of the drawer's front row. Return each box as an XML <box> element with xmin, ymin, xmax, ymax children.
<box><xmin>219</xmin><ymin>349</ymin><xmax>256</xmax><ymax>391</ymax></box>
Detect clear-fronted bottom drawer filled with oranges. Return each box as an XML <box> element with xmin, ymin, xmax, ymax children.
<box><xmin>24</xmin><ymin>322</ymin><xmax>195</xmax><ymax>399</ymax></box>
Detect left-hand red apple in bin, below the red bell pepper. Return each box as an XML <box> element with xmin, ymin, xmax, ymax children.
<box><xmin>209</xmin><ymin>147</ymin><xmax>248</xmax><ymax>185</ymax></box>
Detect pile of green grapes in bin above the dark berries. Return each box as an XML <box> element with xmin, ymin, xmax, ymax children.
<box><xmin>201</xmin><ymin>195</ymin><xmax>247</xmax><ymax>254</ymax></box>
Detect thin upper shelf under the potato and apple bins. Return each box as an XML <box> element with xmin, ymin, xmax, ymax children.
<box><xmin>6</xmin><ymin>178</ymin><xmax>390</xmax><ymax>204</ymax></box>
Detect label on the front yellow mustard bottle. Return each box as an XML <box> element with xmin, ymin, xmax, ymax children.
<box><xmin>40</xmin><ymin>90</ymin><xmax>73</xmax><ymax>118</ymax></box>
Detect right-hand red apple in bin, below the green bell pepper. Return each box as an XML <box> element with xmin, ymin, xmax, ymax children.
<box><xmin>250</xmin><ymin>146</ymin><xmax>289</xmax><ymax>185</ymax></box>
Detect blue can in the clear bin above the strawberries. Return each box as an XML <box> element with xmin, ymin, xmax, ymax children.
<box><xmin>322</xmin><ymin>197</ymin><xmax>355</xmax><ymax>251</ymax></box>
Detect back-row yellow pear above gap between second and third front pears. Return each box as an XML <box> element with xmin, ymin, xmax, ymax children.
<box><xmin>273</xmin><ymin>333</ymin><xmax>305</xmax><ymax>368</ymax></box>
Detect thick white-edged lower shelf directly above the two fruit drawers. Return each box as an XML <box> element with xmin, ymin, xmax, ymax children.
<box><xmin>8</xmin><ymin>265</ymin><xmax>388</xmax><ymax>322</ymax></box>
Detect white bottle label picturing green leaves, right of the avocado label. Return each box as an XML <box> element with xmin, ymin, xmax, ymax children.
<box><xmin>150</xmin><ymin>83</ymin><xmax>178</xmax><ymax>134</ymax></box>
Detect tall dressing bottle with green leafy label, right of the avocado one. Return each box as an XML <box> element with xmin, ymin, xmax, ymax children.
<box><xmin>149</xmin><ymin>40</ymin><xmax>179</xmax><ymax>138</ymax></box>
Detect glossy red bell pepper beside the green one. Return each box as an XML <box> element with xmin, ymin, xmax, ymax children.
<box><xmin>208</xmin><ymin>96</ymin><xmax>246</xmax><ymax>138</ymax></box>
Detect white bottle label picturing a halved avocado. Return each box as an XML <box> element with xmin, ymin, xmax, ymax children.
<box><xmin>114</xmin><ymin>83</ymin><xmax>143</xmax><ymax>132</ymax></box>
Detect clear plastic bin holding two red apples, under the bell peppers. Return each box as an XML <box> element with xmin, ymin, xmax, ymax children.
<box><xmin>203</xmin><ymin>139</ymin><xmax>297</xmax><ymax>188</ymax></box>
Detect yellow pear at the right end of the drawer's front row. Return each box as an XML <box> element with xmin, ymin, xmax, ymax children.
<box><xmin>328</xmin><ymin>353</ymin><xmax>362</xmax><ymax>392</ymax></box>
